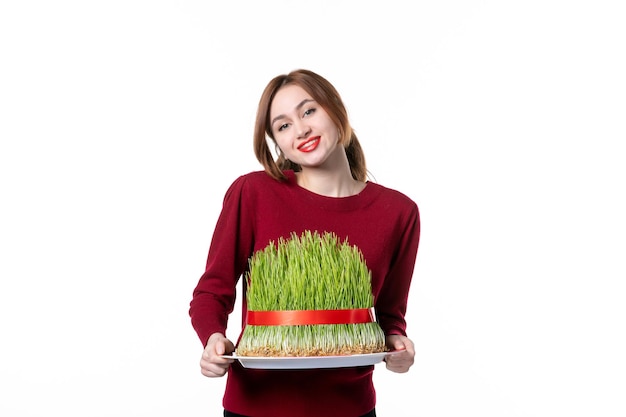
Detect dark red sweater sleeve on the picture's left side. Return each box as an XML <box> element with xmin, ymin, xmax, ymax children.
<box><xmin>189</xmin><ymin>176</ymin><xmax>253</xmax><ymax>346</ymax></box>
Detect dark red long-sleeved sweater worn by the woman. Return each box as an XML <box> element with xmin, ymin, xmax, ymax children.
<box><xmin>189</xmin><ymin>171</ymin><xmax>420</xmax><ymax>417</ymax></box>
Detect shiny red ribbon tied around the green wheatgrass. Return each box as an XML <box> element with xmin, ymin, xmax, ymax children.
<box><xmin>246</xmin><ymin>308</ymin><xmax>376</xmax><ymax>326</ymax></box>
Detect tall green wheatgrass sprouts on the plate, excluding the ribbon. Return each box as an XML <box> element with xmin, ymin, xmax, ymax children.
<box><xmin>237</xmin><ymin>231</ymin><xmax>386</xmax><ymax>356</ymax></box>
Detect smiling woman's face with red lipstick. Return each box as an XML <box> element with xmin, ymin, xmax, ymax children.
<box><xmin>270</xmin><ymin>85</ymin><xmax>340</xmax><ymax>169</ymax></box>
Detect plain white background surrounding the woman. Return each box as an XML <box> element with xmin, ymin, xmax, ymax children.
<box><xmin>0</xmin><ymin>0</ymin><xmax>626</xmax><ymax>417</ymax></box>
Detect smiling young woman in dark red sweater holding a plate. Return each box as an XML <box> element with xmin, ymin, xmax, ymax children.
<box><xmin>189</xmin><ymin>70</ymin><xmax>420</xmax><ymax>417</ymax></box>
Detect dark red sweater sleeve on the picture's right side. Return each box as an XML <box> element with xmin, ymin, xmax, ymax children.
<box><xmin>376</xmin><ymin>200</ymin><xmax>420</xmax><ymax>336</ymax></box>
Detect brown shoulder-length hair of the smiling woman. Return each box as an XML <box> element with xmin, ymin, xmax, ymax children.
<box><xmin>254</xmin><ymin>69</ymin><xmax>367</xmax><ymax>181</ymax></box>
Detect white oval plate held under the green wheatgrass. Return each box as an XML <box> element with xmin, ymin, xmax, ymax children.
<box><xmin>223</xmin><ymin>350</ymin><xmax>401</xmax><ymax>369</ymax></box>
